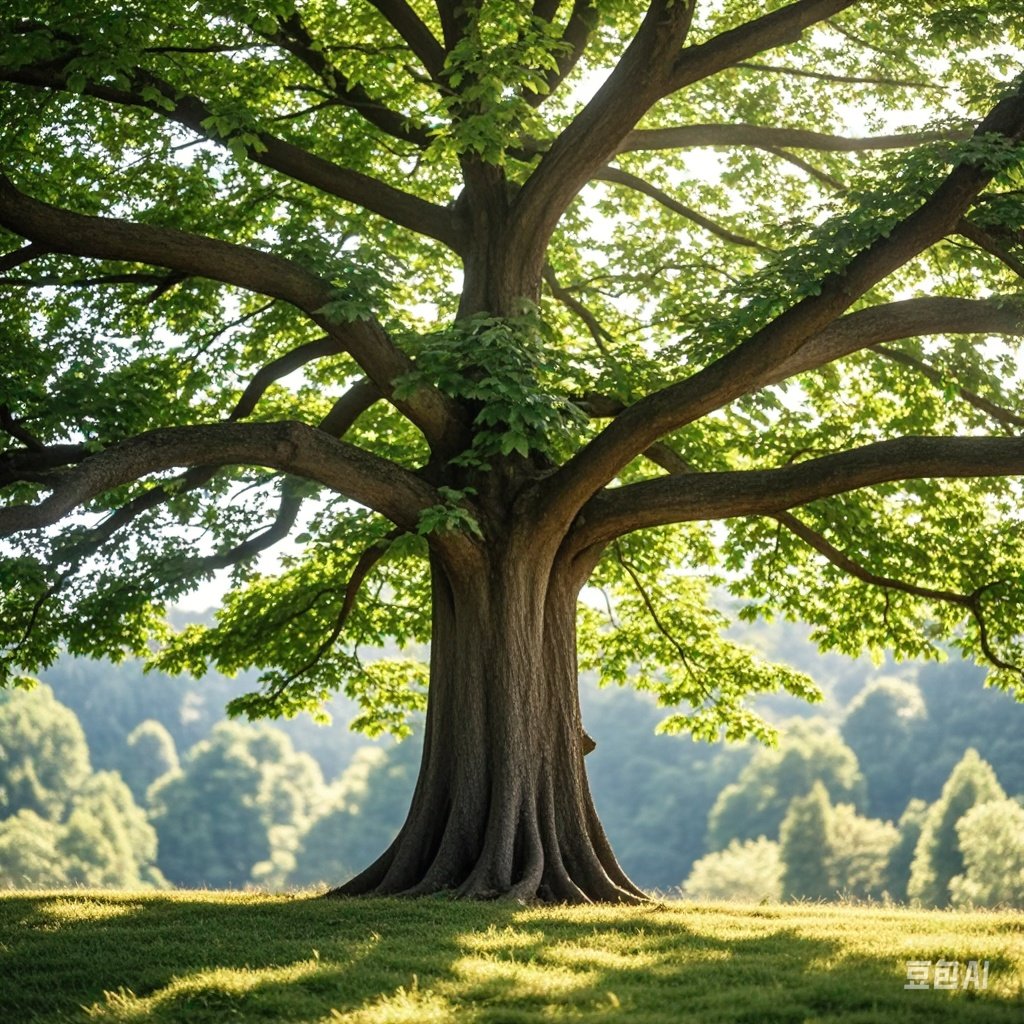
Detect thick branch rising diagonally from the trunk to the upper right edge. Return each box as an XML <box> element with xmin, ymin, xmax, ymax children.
<box><xmin>547</xmin><ymin>79</ymin><xmax>1024</xmax><ymax>528</ymax></box>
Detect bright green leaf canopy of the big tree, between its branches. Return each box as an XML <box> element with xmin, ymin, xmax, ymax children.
<box><xmin>0</xmin><ymin>0</ymin><xmax>1024</xmax><ymax>753</ymax></box>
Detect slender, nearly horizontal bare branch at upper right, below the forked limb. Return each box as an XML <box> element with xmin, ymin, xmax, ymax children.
<box><xmin>617</xmin><ymin>123</ymin><xmax>971</xmax><ymax>153</ymax></box>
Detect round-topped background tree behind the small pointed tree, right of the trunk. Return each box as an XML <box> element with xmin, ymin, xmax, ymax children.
<box><xmin>708</xmin><ymin>720</ymin><xmax>865</xmax><ymax>850</ymax></box>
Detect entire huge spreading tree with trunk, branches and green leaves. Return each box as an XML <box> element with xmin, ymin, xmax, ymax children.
<box><xmin>0</xmin><ymin>0</ymin><xmax>1024</xmax><ymax>900</ymax></box>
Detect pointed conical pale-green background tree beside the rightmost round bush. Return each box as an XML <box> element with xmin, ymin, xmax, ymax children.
<box><xmin>907</xmin><ymin>750</ymin><xmax>1007</xmax><ymax>906</ymax></box>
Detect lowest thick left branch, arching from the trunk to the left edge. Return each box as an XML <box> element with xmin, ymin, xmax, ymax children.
<box><xmin>0</xmin><ymin>422</ymin><xmax>440</xmax><ymax>537</ymax></box>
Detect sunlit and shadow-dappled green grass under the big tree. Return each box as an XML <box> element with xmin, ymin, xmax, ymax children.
<box><xmin>0</xmin><ymin>891</ymin><xmax>1024</xmax><ymax>1024</ymax></box>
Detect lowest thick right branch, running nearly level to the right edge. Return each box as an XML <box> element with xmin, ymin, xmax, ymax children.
<box><xmin>573</xmin><ymin>437</ymin><xmax>1024</xmax><ymax>550</ymax></box>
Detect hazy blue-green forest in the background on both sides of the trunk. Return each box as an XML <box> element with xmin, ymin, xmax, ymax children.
<box><xmin>0</xmin><ymin>624</ymin><xmax>1024</xmax><ymax>906</ymax></box>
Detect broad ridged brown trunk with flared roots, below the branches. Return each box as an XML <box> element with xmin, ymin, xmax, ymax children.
<box><xmin>331</xmin><ymin>549</ymin><xmax>645</xmax><ymax>902</ymax></box>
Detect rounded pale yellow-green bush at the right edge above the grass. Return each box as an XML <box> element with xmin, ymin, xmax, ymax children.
<box><xmin>949</xmin><ymin>800</ymin><xmax>1024</xmax><ymax>906</ymax></box>
